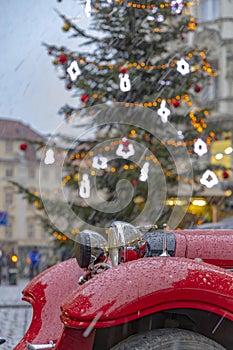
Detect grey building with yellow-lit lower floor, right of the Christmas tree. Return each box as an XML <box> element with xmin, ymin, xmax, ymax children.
<box><xmin>177</xmin><ymin>0</ymin><xmax>233</xmax><ymax>225</ymax></box>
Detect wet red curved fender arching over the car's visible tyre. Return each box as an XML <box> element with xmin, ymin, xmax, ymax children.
<box><xmin>61</xmin><ymin>257</ymin><xmax>233</xmax><ymax>328</ymax></box>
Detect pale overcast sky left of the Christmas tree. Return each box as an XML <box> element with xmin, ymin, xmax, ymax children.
<box><xmin>0</xmin><ymin>0</ymin><xmax>90</xmax><ymax>134</ymax></box>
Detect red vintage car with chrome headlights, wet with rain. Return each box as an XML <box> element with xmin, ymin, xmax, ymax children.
<box><xmin>14</xmin><ymin>222</ymin><xmax>233</xmax><ymax>350</ymax></box>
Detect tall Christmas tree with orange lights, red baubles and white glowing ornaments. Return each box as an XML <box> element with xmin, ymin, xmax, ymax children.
<box><xmin>14</xmin><ymin>0</ymin><xmax>222</xmax><ymax>247</ymax></box>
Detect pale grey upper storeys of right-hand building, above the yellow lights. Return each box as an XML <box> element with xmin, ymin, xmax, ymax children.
<box><xmin>195</xmin><ymin>0</ymin><xmax>233</xmax><ymax>131</ymax></box>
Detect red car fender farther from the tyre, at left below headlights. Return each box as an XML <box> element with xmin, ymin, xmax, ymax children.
<box><xmin>14</xmin><ymin>259</ymin><xmax>83</xmax><ymax>350</ymax></box>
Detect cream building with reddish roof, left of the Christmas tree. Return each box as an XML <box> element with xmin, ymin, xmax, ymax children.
<box><xmin>0</xmin><ymin>119</ymin><xmax>59</xmax><ymax>274</ymax></box>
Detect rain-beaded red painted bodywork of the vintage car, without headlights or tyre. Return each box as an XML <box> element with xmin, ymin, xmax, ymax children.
<box><xmin>14</xmin><ymin>230</ymin><xmax>233</xmax><ymax>350</ymax></box>
